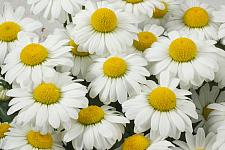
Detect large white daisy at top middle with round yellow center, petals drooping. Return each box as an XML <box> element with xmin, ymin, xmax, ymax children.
<box><xmin>74</xmin><ymin>1</ymin><xmax>139</xmax><ymax>55</ymax></box>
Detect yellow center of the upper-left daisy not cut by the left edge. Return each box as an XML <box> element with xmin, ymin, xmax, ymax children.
<box><xmin>20</xmin><ymin>43</ymin><xmax>48</xmax><ymax>66</ymax></box>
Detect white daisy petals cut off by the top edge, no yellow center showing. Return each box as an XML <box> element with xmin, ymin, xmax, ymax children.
<box><xmin>27</xmin><ymin>0</ymin><xmax>86</xmax><ymax>19</ymax></box>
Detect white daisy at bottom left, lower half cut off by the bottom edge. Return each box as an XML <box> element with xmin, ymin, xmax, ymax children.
<box><xmin>3</xmin><ymin>125</ymin><xmax>64</xmax><ymax>150</ymax></box>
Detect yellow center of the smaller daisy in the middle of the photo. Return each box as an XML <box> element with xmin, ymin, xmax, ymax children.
<box><xmin>103</xmin><ymin>57</ymin><xmax>127</xmax><ymax>78</ymax></box>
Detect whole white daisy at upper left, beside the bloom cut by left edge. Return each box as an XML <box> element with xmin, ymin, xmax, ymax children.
<box><xmin>2</xmin><ymin>32</ymin><xmax>73</xmax><ymax>84</ymax></box>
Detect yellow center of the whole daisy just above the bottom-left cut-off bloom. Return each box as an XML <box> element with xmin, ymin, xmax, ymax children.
<box><xmin>33</xmin><ymin>83</ymin><xmax>61</xmax><ymax>105</ymax></box>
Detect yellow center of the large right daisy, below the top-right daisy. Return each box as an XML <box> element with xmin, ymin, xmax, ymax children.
<box><xmin>169</xmin><ymin>38</ymin><xmax>197</xmax><ymax>62</ymax></box>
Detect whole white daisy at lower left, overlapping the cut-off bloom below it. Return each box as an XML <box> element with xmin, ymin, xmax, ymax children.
<box><xmin>7</xmin><ymin>73</ymin><xmax>88</xmax><ymax>133</ymax></box>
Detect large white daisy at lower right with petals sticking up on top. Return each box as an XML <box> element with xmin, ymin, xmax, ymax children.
<box><xmin>122</xmin><ymin>72</ymin><xmax>198</xmax><ymax>138</ymax></box>
